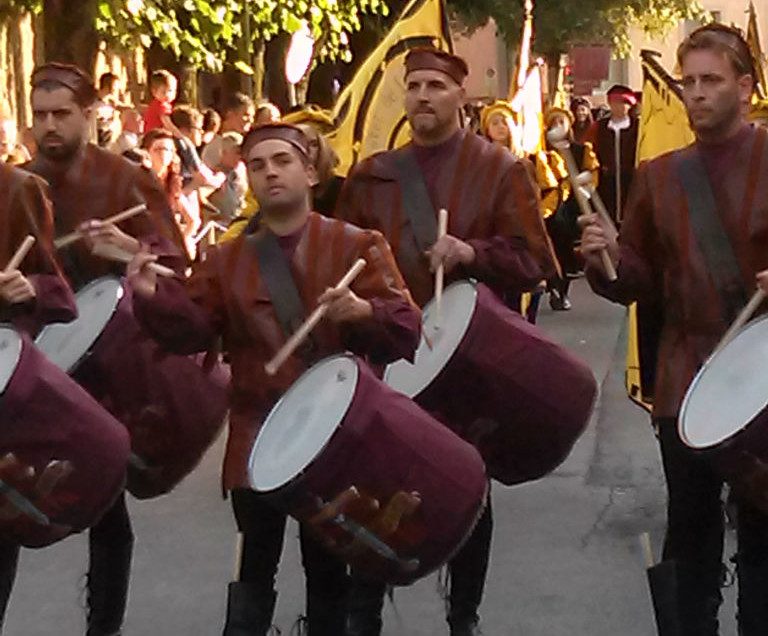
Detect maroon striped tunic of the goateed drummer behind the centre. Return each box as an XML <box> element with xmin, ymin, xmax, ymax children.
<box><xmin>336</xmin><ymin>131</ymin><xmax>555</xmax><ymax>306</ymax></box>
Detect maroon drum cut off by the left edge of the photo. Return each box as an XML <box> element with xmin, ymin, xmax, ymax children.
<box><xmin>0</xmin><ymin>327</ymin><xmax>129</xmax><ymax>547</ymax></box>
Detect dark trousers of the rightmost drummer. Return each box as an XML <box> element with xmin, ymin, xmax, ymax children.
<box><xmin>657</xmin><ymin>418</ymin><xmax>768</xmax><ymax>636</ymax></box>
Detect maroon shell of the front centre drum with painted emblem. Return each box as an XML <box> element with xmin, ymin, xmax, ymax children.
<box><xmin>256</xmin><ymin>362</ymin><xmax>488</xmax><ymax>585</ymax></box>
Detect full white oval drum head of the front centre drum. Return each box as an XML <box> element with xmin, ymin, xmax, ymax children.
<box><xmin>248</xmin><ymin>355</ymin><xmax>359</xmax><ymax>492</ymax></box>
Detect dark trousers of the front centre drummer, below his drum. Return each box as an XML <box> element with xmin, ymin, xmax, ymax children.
<box><xmin>232</xmin><ymin>489</ymin><xmax>347</xmax><ymax>636</ymax></box>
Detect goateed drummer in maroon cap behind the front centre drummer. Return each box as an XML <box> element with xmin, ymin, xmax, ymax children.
<box><xmin>336</xmin><ymin>49</ymin><xmax>556</xmax><ymax>636</ymax></box>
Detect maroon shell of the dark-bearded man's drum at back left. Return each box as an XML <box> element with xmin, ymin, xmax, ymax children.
<box><xmin>73</xmin><ymin>288</ymin><xmax>229</xmax><ymax>499</ymax></box>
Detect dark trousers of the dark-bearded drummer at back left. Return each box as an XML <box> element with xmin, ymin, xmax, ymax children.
<box><xmin>0</xmin><ymin>493</ymin><xmax>133</xmax><ymax>636</ymax></box>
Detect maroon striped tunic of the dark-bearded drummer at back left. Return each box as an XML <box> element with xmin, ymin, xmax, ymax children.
<box><xmin>26</xmin><ymin>144</ymin><xmax>185</xmax><ymax>290</ymax></box>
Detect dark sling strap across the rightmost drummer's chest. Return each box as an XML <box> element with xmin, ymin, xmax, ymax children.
<box><xmin>677</xmin><ymin>148</ymin><xmax>747</xmax><ymax>324</ymax></box>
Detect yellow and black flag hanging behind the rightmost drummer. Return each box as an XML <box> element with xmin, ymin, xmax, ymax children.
<box><xmin>626</xmin><ymin>51</ymin><xmax>695</xmax><ymax>410</ymax></box>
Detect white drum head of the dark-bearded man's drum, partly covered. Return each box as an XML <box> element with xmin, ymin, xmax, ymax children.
<box><xmin>35</xmin><ymin>276</ymin><xmax>124</xmax><ymax>372</ymax></box>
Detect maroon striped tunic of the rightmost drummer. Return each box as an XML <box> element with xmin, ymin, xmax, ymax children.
<box><xmin>587</xmin><ymin>127</ymin><xmax>768</xmax><ymax>417</ymax></box>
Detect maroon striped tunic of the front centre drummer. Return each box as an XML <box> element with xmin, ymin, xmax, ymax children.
<box><xmin>135</xmin><ymin>213</ymin><xmax>420</xmax><ymax>489</ymax></box>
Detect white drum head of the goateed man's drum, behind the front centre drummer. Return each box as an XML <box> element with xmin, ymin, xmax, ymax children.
<box><xmin>383</xmin><ymin>281</ymin><xmax>477</xmax><ymax>397</ymax></box>
